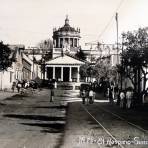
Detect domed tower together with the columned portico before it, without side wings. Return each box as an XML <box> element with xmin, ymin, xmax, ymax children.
<box><xmin>46</xmin><ymin>16</ymin><xmax>85</xmax><ymax>82</ymax></box>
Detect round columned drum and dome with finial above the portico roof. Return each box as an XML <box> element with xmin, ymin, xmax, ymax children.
<box><xmin>52</xmin><ymin>16</ymin><xmax>80</xmax><ymax>58</ymax></box>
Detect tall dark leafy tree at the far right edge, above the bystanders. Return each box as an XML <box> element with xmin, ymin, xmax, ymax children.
<box><xmin>120</xmin><ymin>28</ymin><xmax>148</xmax><ymax>102</ymax></box>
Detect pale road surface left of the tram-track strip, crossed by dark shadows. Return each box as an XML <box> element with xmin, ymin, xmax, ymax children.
<box><xmin>0</xmin><ymin>90</ymin><xmax>66</xmax><ymax>148</ymax></box>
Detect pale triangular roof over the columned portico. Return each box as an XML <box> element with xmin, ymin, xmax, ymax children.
<box><xmin>46</xmin><ymin>55</ymin><xmax>85</xmax><ymax>66</ymax></box>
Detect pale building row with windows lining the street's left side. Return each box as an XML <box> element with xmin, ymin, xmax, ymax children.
<box><xmin>0</xmin><ymin>45</ymin><xmax>39</xmax><ymax>90</ymax></box>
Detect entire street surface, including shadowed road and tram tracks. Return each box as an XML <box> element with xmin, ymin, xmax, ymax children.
<box><xmin>0</xmin><ymin>89</ymin><xmax>148</xmax><ymax>148</ymax></box>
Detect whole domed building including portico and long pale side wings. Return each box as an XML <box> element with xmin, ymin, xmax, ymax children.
<box><xmin>20</xmin><ymin>16</ymin><xmax>117</xmax><ymax>82</ymax></box>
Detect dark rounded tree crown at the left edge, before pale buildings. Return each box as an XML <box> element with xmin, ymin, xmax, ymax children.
<box><xmin>0</xmin><ymin>41</ymin><xmax>15</xmax><ymax>71</ymax></box>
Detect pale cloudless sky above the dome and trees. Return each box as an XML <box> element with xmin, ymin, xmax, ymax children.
<box><xmin>0</xmin><ymin>0</ymin><xmax>148</xmax><ymax>47</ymax></box>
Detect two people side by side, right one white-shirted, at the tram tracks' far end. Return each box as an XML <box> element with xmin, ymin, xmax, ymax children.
<box><xmin>81</xmin><ymin>89</ymin><xmax>95</xmax><ymax>104</ymax></box>
